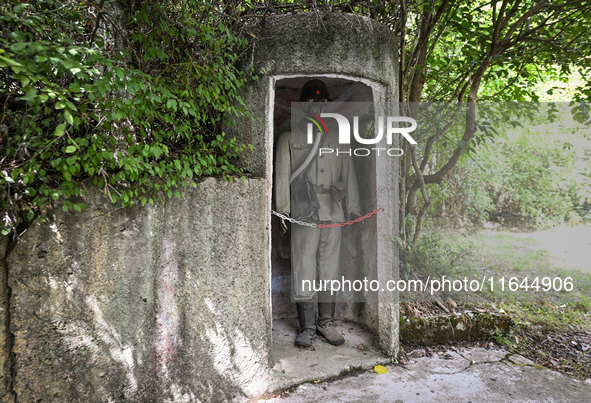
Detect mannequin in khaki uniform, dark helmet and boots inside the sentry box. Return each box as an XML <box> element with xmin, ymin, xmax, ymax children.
<box><xmin>274</xmin><ymin>80</ymin><xmax>360</xmax><ymax>347</ymax></box>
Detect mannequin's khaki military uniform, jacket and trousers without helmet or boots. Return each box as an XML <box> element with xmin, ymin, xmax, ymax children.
<box><xmin>274</xmin><ymin>130</ymin><xmax>360</xmax><ymax>301</ymax></box>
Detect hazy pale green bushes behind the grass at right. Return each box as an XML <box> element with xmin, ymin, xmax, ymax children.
<box><xmin>431</xmin><ymin>104</ymin><xmax>591</xmax><ymax>227</ymax></box>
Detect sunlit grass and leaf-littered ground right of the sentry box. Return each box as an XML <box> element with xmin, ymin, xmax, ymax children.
<box><xmin>401</xmin><ymin>226</ymin><xmax>591</xmax><ymax>380</ymax></box>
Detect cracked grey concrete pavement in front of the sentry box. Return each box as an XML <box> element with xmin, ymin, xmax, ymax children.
<box><xmin>270</xmin><ymin>349</ymin><xmax>591</xmax><ymax>403</ymax></box>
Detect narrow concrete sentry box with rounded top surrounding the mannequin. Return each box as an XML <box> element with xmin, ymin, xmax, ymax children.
<box><xmin>231</xmin><ymin>13</ymin><xmax>399</xmax><ymax>366</ymax></box>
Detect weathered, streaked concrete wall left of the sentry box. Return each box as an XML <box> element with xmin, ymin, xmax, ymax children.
<box><xmin>7</xmin><ymin>179</ymin><xmax>271</xmax><ymax>402</ymax></box>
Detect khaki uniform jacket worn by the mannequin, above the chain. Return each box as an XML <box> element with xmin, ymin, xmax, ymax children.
<box><xmin>273</xmin><ymin>130</ymin><xmax>361</xmax><ymax>223</ymax></box>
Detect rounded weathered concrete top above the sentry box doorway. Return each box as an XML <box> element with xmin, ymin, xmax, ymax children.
<box><xmin>250</xmin><ymin>12</ymin><xmax>398</xmax><ymax>85</ymax></box>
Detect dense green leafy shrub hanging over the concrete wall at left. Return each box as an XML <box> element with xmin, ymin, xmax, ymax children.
<box><xmin>0</xmin><ymin>0</ymin><xmax>251</xmax><ymax>234</ymax></box>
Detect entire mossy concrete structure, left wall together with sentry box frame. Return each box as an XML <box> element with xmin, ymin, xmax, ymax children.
<box><xmin>0</xmin><ymin>13</ymin><xmax>398</xmax><ymax>402</ymax></box>
